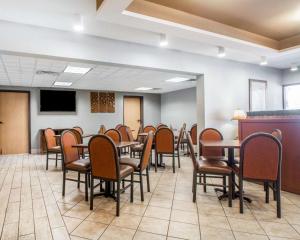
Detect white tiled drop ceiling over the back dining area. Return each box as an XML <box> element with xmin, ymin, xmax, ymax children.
<box><xmin>0</xmin><ymin>54</ymin><xmax>196</xmax><ymax>93</ymax></box>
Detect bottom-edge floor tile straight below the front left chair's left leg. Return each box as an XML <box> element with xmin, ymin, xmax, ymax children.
<box><xmin>72</xmin><ymin>221</ymin><xmax>107</xmax><ymax>239</ymax></box>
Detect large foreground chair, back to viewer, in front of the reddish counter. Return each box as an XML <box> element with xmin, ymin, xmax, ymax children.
<box><xmin>234</xmin><ymin>132</ymin><xmax>282</xmax><ymax>218</ymax></box>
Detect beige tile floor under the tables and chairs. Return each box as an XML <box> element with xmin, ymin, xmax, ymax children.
<box><xmin>0</xmin><ymin>155</ymin><xmax>300</xmax><ymax>240</ymax></box>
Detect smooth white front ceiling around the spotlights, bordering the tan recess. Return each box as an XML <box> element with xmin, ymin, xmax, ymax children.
<box><xmin>0</xmin><ymin>0</ymin><xmax>300</xmax><ymax>69</ymax></box>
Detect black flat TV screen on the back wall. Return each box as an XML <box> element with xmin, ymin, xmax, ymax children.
<box><xmin>40</xmin><ymin>90</ymin><xmax>76</xmax><ymax>112</ymax></box>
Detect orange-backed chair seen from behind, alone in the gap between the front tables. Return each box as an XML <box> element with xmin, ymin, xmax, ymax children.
<box><xmin>155</xmin><ymin>128</ymin><xmax>180</xmax><ymax>173</ymax></box>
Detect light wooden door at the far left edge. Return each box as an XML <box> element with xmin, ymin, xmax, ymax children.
<box><xmin>0</xmin><ymin>92</ymin><xmax>29</xmax><ymax>154</ymax></box>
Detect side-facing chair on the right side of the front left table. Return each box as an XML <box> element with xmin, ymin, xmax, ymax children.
<box><xmin>120</xmin><ymin>132</ymin><xmax>153</xmax><ymax>201</ymax></box>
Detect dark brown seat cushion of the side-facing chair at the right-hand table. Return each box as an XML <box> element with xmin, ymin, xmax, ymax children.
<box><xmin>198</xmin><ymin>160</ymin><xmax>232</xmax><ymax>174</ymax></box>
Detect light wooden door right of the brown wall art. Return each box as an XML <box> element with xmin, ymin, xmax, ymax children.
<box><xmin>124</xmin><ymin>96</ymin><xmax>143</xmax><ymax>138</ymax></box>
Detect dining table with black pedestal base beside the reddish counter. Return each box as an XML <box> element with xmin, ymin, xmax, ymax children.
<box><xmin>199</xmin><ymin>139</ymin><xmax>251</xmax><ymax>202</ymax></box>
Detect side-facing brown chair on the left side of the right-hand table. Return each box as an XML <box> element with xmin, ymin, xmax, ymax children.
<box><xmin>187</xmin><ymin>134</ymin><xmax>233</xmax><ymax>207</ymax></box>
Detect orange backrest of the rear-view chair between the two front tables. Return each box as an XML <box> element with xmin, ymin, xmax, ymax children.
<box><xmin>155</xmin><ymin>128</ymin><xmax>174</xmax><ymax>154</ymax></box>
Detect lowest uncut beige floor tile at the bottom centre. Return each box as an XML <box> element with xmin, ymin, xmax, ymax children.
<box><xmin>138</xmin><ymin>217</ymin><xmax>169</xmax><ymax>235</ymax></box>
